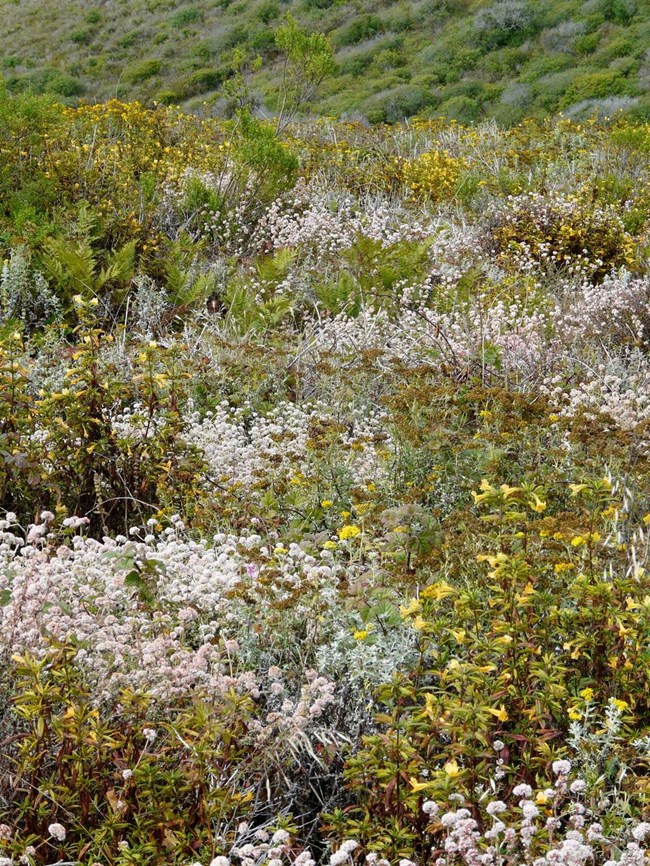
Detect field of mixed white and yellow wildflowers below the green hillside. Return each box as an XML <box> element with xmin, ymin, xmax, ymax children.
<box><xmin>0</xmin><ymin>86</ymin><xmax>650</xmax><ymax>866</ymax></box>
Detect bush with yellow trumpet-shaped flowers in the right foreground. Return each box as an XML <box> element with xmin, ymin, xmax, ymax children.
<box><xmin>334</xmin><ymin>478</ymin><xmax>650</xmax><ymax>856</ymax></box>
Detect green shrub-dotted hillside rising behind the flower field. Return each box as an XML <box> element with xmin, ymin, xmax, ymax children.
<box><xmin>0</xmin><ymin>0</ymin><xmax>650</xmax><ymax>124</ymax></box>
